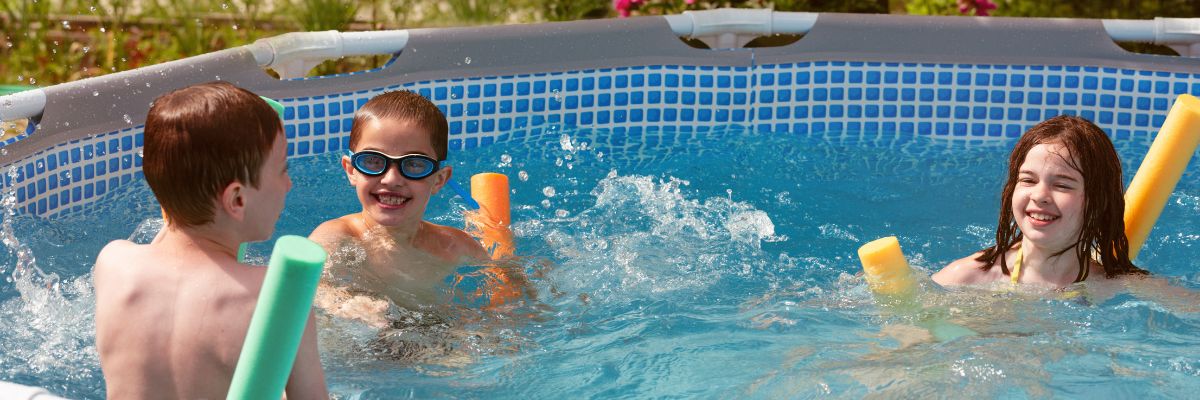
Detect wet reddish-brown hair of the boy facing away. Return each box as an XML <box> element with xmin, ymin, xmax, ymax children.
<box><xmin>142</xmin><ymin>82</ymin><xmax>282</xmax><ymax>227</ymax></box>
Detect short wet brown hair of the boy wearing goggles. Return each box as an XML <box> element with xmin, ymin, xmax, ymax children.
<box><xmin>350</xmin><ymin>90</ymin><xmax>450</xmax><ymax>161</ymax></box>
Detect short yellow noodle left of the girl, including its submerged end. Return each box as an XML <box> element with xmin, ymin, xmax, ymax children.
<box><xmin>858</xmin><ymin>237</ymin><xmax>976</xmax><ymax>341</ymax></box>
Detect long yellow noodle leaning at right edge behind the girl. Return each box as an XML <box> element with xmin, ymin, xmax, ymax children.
<box><xmin>1124</xmin><ymin>94</ymin><xmax>1200</xmax><ymax>259</ymax></box>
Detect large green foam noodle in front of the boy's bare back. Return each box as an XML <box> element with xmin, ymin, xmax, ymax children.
<box><xmin>226</xmin><ymin>235</ymin><xmax>326</xmax><ymax>400</ymax></box>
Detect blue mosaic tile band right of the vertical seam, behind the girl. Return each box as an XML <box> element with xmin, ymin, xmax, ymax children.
<box><xmin>754</xmin><ymin>62</ymin><xmax>1200</xmax><ymax>141</ymax></box>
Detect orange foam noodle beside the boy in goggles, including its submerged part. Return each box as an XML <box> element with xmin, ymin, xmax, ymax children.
<box><xmin>467</xmin><ymin>172</ymin><xmax>521</xmax><ymax>306</ymax></box>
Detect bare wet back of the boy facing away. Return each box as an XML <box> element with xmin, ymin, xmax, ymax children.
<box><xmin>94</xmin><ymin>236</ymin><xmax>265</xmax><ymax>399</ymax></box>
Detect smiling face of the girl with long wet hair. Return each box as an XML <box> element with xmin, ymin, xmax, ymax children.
<box><xmin>1012</xmin><ymin>143</ymin><xmax>1084</xmax><ymax>251</ymax></box>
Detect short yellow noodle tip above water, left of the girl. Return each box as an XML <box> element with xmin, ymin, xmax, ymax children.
<box><xmin>858</xmin><ymin>237</ymin><xmax>916</xmax><ymax>295</ymax></box>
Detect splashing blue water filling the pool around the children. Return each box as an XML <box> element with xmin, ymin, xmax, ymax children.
<box><xmin>0</xmin><ymin>126</ymin><xmax>1200</xmax><ymax>399</ymax></box>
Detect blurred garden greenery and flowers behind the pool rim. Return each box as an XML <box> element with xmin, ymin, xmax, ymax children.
<box><xmin>0</xmin><ymin>0</ymin><xmax>1200</xmax><ymax>133</ymax></box>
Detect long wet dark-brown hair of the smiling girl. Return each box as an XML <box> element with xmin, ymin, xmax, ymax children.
<box><xmin>976</xmin><ymin>115</ymin><xmax>1146</xmax><ymax>278</ymax></box>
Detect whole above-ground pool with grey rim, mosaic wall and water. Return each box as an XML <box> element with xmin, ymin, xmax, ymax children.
<box><xmin>0</xmin><ymin>10</ymin><xmax>1200</xmax><ymax>399</ymax></box>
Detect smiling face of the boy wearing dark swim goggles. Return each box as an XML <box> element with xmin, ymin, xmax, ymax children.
<box><xmin>342</xmin><ymin>118</ymin><xmax>450</xmax><ymax>227</ymax></box>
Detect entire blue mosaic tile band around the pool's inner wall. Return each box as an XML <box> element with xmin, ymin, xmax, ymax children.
<box><xmin>0</xmin><ymin>61</ymin><xmax>1200</xmax><ymax>215</ymax></box>
